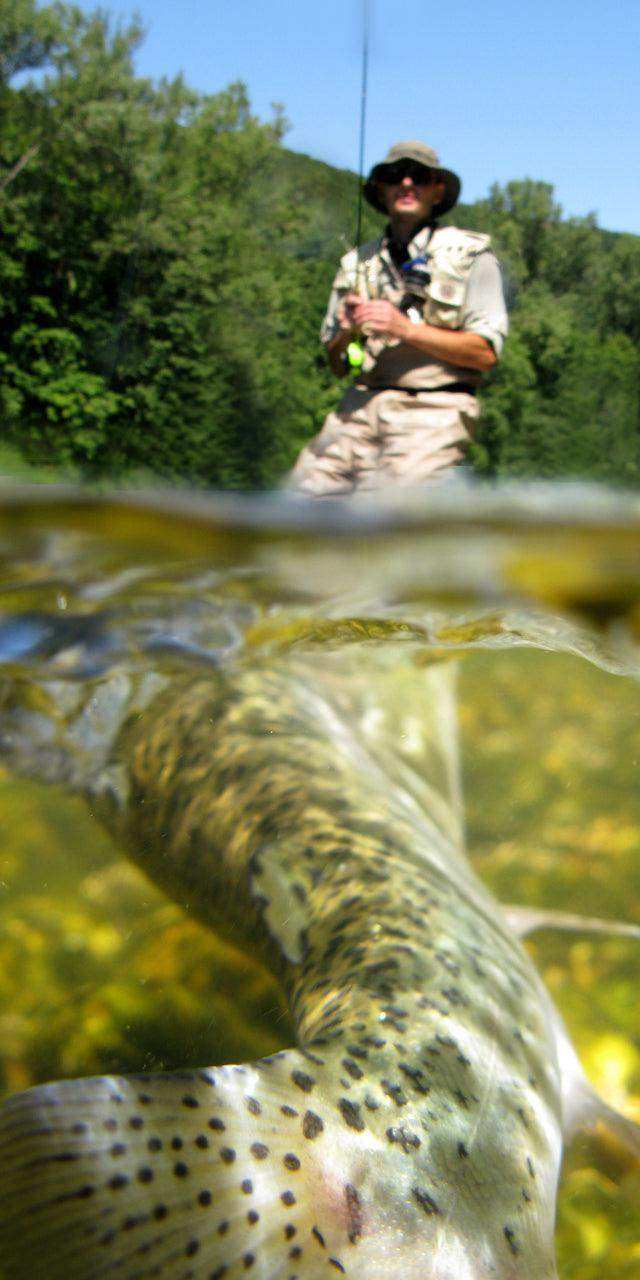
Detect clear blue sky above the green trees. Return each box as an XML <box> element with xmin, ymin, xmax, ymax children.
<box><xmin>77</xmin><ymin>0</ymin><xmax>640</xmax><ymax>234</ymax></box>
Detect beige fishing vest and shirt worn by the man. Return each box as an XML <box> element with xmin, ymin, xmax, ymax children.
<box><xmin>320</xmin><ymin>227</ymin><xmax>508</xmax><ymax>390</ymax></box>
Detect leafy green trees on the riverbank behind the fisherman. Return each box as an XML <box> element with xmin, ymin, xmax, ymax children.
<box><xmin>0</xmin><ymin>0</ymin><xmax>640</xmax><ymax>489</ymax></box>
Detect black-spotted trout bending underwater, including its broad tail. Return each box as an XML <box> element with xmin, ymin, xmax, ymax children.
<box><xmin>0</xmin><ymin>654</ymin><xmax>627</xmax><ymax>1280</ymax></box>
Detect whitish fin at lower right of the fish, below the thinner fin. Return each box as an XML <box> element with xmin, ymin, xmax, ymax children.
<box><xmin>556</xmin><ymin>1014</ymin><xmax>640</xmax><ymax>1162</ymax></box>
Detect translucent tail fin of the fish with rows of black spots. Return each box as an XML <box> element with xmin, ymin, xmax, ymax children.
<box><xmin>0</xmin><ymin>1051</ymin><xmax>361</xmax><ymax>1280</ymax></box>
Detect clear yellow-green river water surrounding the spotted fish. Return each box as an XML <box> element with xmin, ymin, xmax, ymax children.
<box><xmin>0</xmin><ymin>483</ymin><xmax>640</xmax><ymax>1280</ymax></box>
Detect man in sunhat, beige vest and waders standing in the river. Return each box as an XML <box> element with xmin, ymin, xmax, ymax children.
<box><xmin>289</xmin><ymin>141</ymin><xmax>507</xmax><ymax>498</ymax></box>
